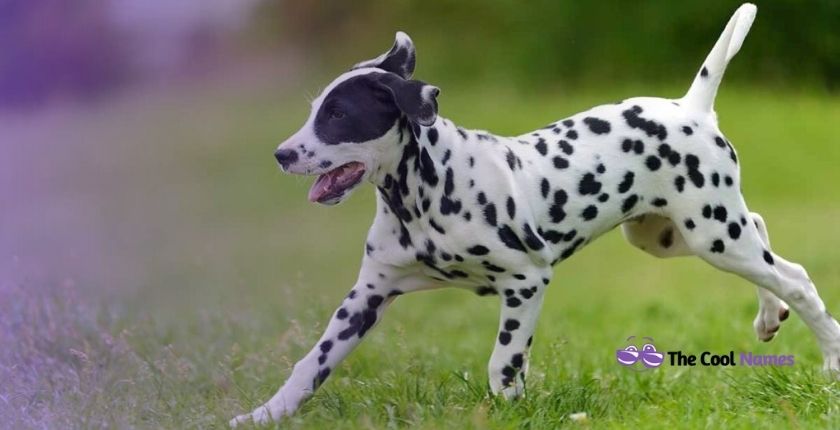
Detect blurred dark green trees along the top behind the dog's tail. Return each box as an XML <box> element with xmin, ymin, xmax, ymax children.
<box><xmin>257</xmin><ymin>0</ymin><xmax>840</xmax><ymax>89</ymax></box>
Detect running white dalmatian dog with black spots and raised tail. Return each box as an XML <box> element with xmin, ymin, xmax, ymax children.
<box><xmin>231</xmin><ymin>4</ymin><xmax>840</xmax><ymax>426</ymax></box>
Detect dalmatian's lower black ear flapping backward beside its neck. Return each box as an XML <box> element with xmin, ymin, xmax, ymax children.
<box><xmin>378</xmin><ymin>73</ymin><xmax>440</xmax><ymax>126</ymax></box>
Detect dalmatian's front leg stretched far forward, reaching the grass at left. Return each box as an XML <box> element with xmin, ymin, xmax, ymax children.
<box><xmin>230</xmin><ymin>259</ymin><xmax>423</xmax><ymax>427</ymax></box>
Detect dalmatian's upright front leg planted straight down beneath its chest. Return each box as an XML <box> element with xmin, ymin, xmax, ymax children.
<box><xmin>488</xmin><ymin>278</ymin><xmax>548</xmax><ymax>399</ymax></box>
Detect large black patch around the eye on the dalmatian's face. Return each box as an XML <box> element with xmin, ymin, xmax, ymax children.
<box><xmin>314</xmin><ymin>73</ymin><xmax>401</xmax><ymax>145</ymax></box>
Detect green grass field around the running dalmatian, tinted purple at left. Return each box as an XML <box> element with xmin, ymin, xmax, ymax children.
<box><xmin>0</xmin><ymin>78</ymin><xmax>840</xmax><ymax>429</ymax></box>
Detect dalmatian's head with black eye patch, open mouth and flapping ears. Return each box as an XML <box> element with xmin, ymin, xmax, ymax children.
<box><xmin>274</xmin><ymin>32</ymin><xmax>440</xmax><ymax>205</ymax></box>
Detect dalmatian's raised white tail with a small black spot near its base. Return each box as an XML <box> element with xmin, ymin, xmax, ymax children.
<box><xmin>682</xmin><ymin>3</ymin><xmax>756</xmax><ymax>112</ymax></box>
